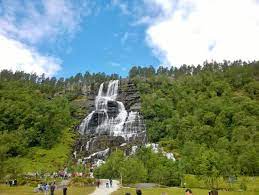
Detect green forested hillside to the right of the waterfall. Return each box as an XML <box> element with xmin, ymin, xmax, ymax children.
<box><xmin>130</xmin><ymin>61</ymin><xmax>259</xmax><ymax>178</ymax></box>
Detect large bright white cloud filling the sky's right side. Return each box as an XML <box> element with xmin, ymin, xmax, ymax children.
<box><xmin>143</xmin><ymin>0</ymin><xmax>259</xmax><ymax>66</ymax></box>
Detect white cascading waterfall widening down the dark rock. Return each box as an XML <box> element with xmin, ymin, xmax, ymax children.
<box><xmin>79</xmin><ymin>80</ymin><xmax>145</xmax><ymax>140</ymax></box>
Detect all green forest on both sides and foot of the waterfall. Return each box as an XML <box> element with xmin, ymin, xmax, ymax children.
<box><xmin>0</xmin><ymin>61</ymin><xmax>259</xmax><ymax>186</ymax></box>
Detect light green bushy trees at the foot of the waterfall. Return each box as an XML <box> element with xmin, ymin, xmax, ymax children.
<box><xmin>94</xmin><ymin>148</ymin><xmax>181</xmax><ymax>186</ymax></box>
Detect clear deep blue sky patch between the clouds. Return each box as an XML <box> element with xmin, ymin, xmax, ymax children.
<box><xmin>55</xmin><ymin>2</ymin><xmax>159</xmax><ymax>76</ymax></box>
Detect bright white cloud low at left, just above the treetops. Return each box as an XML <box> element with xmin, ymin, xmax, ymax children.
<box><xmin>0</xmin><ymin>34</ymin><xmax>61</xmax><ymax>76</ymax></box>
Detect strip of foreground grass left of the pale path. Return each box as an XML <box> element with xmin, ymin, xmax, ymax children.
<box><xmin>0</xmin><ymin>185</ymin><xmax>95</xmax><ymax>195</ymax></box>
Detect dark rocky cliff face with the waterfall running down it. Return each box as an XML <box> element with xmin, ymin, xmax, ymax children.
<box><xmin>74</xmin><ymin>79</ymin><xmax>146</xmax><ymax>163</ymax></box>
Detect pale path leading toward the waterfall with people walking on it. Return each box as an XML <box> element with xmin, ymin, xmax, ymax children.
<box><xmin>90</xmin><ymin>179</ymin><xmax>119</xmax><ymax>195</ymax></box>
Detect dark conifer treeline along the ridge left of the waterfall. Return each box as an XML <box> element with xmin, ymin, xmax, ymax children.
<box><xmin>0</xmin><ymin>70</ymin><xmax>121</xmax><ymax>96</ymax></box>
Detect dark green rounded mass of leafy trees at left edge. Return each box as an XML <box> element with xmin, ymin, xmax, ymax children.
<box><xmin>0</xmin><ymin>81</ymin><xmax>71</xmax><ymax>149</ymax></box>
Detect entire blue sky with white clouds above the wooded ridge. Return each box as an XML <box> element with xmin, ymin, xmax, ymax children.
<box><xmin>0</xmin><ymin>0</ymin><xmax>259</xmax><ymax>77</ymax></box>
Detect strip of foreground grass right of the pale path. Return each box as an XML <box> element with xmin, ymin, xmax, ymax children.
<box><xmin>112</xmin><ymin>188</ymin><xmax>259</xmax><ymax>195</ymax></box>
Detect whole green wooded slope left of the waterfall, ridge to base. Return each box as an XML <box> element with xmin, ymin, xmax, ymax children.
<box><xmin>0</xmin><ymin>70</ymin><xmax>119</xmax><ymax>177</ymax></box>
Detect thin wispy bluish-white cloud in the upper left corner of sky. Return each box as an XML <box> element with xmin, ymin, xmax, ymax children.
<box><xmin>0</xmin><ymin>0</ymin><xmax>89</xmax><ymax>44</ymax></box>
